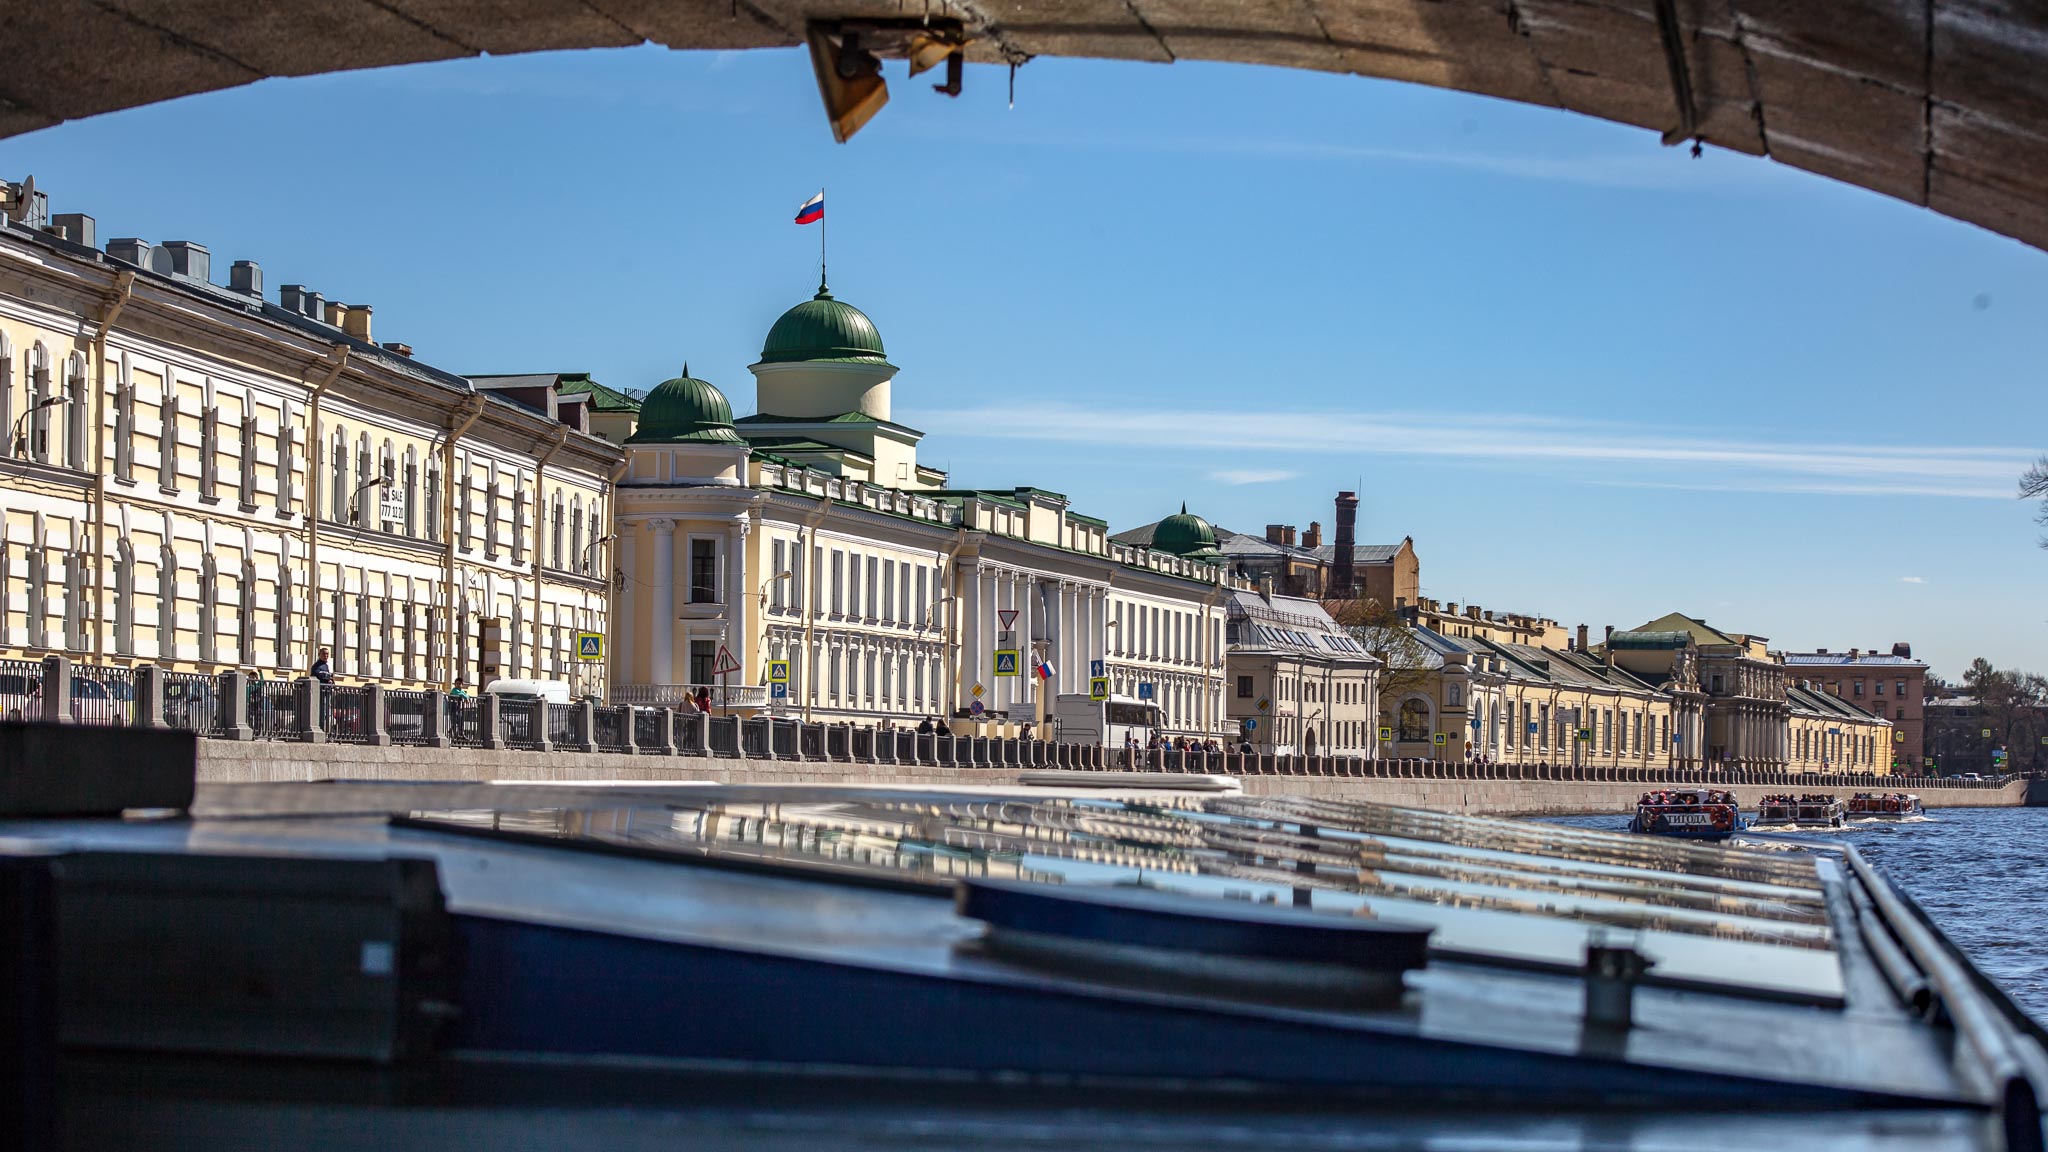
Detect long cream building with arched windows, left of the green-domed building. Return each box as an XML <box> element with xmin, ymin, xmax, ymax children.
<box><xmin>0</xmin><ymin>175</ymin><xmax>621</xmax><ymax>691</ymax></box>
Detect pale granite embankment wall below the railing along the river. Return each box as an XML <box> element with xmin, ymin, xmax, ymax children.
<box><xmin>199</xmin><ymin>740</ymin><xmax>2028</xmax><ymax>816</ymax></box>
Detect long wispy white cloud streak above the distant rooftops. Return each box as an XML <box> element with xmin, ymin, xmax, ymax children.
<box><xmin>924</xmin><ymin>406</ymin><xmax>2036</xmax><ymax>500</ymax></box>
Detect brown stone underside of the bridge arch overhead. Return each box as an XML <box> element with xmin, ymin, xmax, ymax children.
<box><xmin>0</xmin><ymin>0</ymin><xmax>2048</xmax><ymax>248</ymax></box>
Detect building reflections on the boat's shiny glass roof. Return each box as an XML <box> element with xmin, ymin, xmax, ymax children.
<box><xmin>416</xmin><ymin>793</ymin><xmax>1841</xmax><ymax>1000</ymax></box>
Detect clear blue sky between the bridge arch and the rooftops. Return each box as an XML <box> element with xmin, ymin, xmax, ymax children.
<box><xmin>0</xmin><ymin>49</ymin><xmax>2048</xmax><ymax>676</ymax></box>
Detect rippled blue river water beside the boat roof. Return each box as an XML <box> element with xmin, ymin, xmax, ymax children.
<box><xmin>1559</xmin><ymin>808</ymin><xmax>2048</xmax><ymax>1021</ymax></box>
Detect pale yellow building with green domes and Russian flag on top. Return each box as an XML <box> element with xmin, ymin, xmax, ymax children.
<box><xmin>612</xmin><ymin>278</ymin><xmax>1231</xmax><ymax>738</ymax></box>
